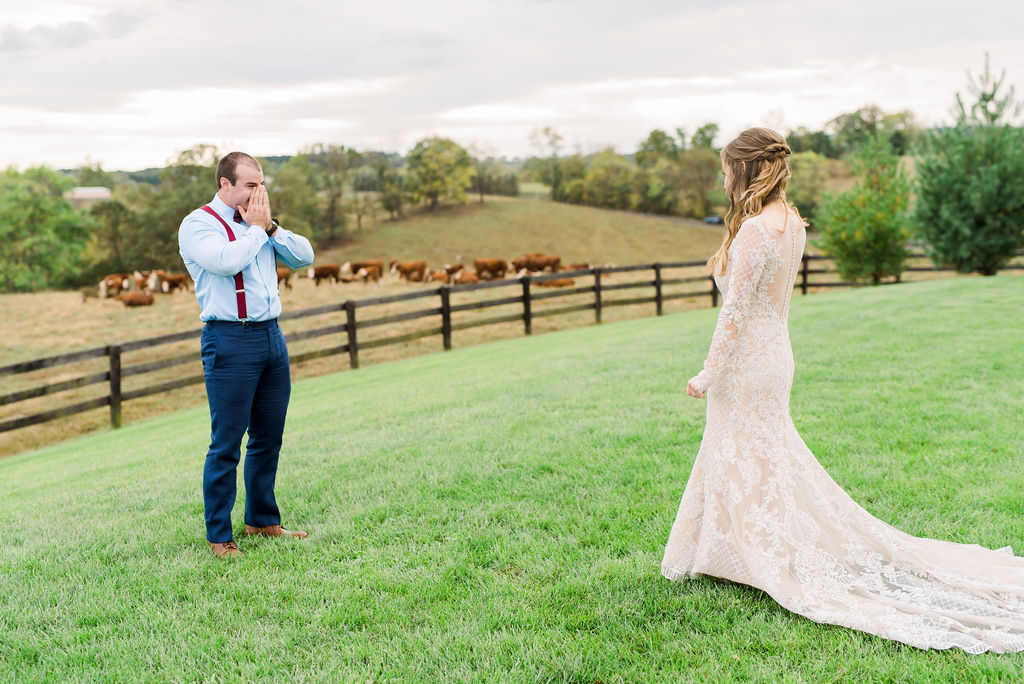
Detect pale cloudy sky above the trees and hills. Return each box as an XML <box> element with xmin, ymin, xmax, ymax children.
<box><xmin>0</xmin><ymin>0</ymin><xmax>1024</xmax><ymax>170</ymax></box>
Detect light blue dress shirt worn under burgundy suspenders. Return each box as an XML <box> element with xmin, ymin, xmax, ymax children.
<box><xmin>178</xmin><ymin>196</ymin><xmax>313</xmax><ymax>322</ymax></box>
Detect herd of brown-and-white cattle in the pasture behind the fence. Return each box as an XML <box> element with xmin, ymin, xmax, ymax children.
<box><xmin>98</xmin><ymin>252</ymin><xmax>590</xmax><ymax>306</ymax></box>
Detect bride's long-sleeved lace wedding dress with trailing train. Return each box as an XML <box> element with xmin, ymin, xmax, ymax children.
<box><xmin>662</xmin><ymin>213</ymin><xmax>1024</xmax><ymax>653</ymax></box>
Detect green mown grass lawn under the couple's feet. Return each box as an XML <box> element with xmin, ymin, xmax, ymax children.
<box><xmin>0</xmin><ymin>276</ymin><xmax>1024</xmax><ymax>682</ymax></box>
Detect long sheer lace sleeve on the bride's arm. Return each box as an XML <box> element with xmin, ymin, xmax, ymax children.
<box><xmin>691</xmin><ymin>221</ymin><xmax>768</xmax><ymax>392</ymax></box>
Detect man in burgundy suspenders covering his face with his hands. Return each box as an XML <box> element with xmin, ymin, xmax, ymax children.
<box><xmin>178</xmin><ymin>152</ymin><xmax>313</xmax><ymax>558</ymax></box>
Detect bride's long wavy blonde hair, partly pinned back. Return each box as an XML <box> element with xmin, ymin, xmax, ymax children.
<box><xmin>708</xmin><ymin>128</ymin><xmax>800</xmax><ymax>274</ymax></box>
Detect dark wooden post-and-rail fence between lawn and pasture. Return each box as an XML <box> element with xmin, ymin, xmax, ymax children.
<box><xmin>0</xmin><ymin>252</ymin><xmax>1024</xmax><ymax>432</ymax></box>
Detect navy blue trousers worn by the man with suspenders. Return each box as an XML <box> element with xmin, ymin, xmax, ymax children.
<box><xmin>201</xmin><ymin>320</ymin><xmax>292</xmax><ymax>543</ymax></box>
